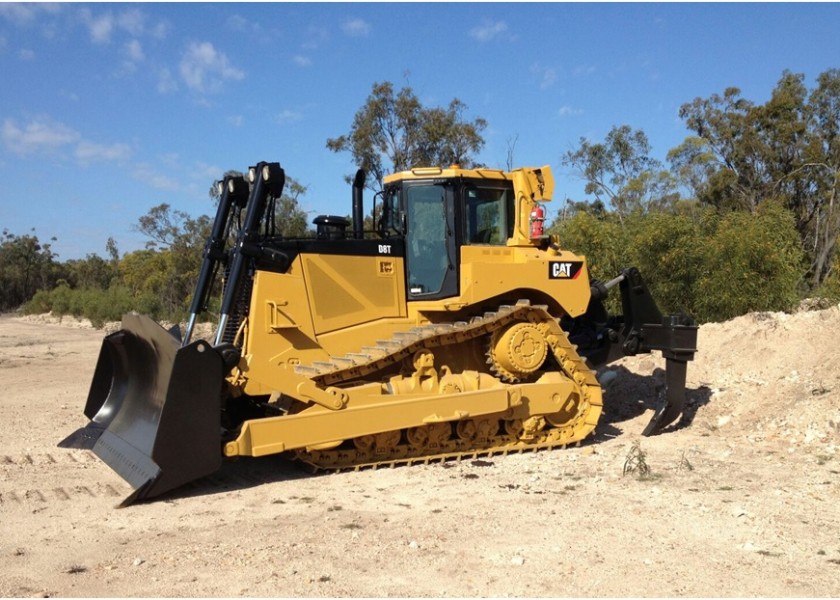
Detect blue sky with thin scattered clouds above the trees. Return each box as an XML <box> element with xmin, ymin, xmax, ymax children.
<box><xmin>0</xmin><ymin>3</ymin><xmax>840</xmax><ymax>260</ymax></box>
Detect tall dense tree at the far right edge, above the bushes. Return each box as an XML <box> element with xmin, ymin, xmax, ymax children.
<box><xmin>669</xmin><ymin>69</ymin><xmax>840</xmax><ymax>288</ymax></box>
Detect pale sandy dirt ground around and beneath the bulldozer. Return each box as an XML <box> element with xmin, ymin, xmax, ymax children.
<box><xmin>0</xmin><ymin>306</ymin><xmax>840</xmax><ymax>597</ymax></box>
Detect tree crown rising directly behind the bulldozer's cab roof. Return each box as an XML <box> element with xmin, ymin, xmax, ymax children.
<box><xmin>327</xmin><ymin>81</ymin><xmax>487</xmax><ymax>191</ymax></box>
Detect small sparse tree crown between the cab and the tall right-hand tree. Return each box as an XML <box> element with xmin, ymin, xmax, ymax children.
<box><xmin>562</xmin><ymin>125</ymin><xmax>679</xmax><ymax>222</ymax></box>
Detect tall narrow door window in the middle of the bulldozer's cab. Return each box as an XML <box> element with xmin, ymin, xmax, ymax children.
<box><xmin>406</xmin><ymin>185</ymin><xmax>449</xmax><ymax>295</ymax></box>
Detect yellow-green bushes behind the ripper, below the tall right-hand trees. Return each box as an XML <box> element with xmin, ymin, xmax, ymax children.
<box><xmin>552</xmin><ymin>204</ymin><xmax>803</xmax><ymax>322</ymax></box>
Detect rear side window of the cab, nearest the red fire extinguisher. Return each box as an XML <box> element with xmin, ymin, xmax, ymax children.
<box><xmin>464</xmin><ymin>186</ymin><xmax>513</xmax><ymax>245</ymax></box>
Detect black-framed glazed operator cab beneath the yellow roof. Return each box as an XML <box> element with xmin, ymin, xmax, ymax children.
<box><xmin>379</xmin><ymin>169</ymin><xmax>514</xmax><ymax>300</ymax></box>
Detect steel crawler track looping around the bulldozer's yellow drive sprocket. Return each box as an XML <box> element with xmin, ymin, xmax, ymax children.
<box><xmin>297</xmin><ymin>301</ymin><xmax>602</xmax><ymax>470</ymax></box>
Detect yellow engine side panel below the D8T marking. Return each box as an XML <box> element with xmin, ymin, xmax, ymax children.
<box><xmin>240</xmin><ymin>251</ymin><xmax>406</xmax><ymax>396</ymax></box>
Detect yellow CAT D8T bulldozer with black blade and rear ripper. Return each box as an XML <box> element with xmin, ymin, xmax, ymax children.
<box><xmin>59</xmin><ymin>162</ymin><xmax>697</xmax><ymax>505</ymax></box>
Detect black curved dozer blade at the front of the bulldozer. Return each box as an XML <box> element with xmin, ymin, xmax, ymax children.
<box><xmin>59</xmin><ymin>313</ymin><xmax>223</xmax><ymax>506</ymax></box>
